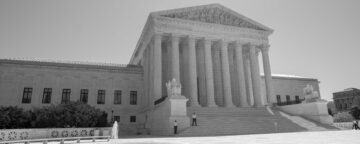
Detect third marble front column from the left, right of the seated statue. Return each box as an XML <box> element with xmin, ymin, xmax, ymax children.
<box><xmin>188</xmin><ymin>36</ymin><xmax>200</xmax><ymax>107</ymax></box>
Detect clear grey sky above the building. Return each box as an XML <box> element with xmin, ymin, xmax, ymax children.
<box><xmin>0</xmin><ymin>0</ymin><xmax>360</xmax><ymax>100</ymax></box>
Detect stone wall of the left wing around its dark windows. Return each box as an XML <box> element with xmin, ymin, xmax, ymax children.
<box><xmin>0</xmin><ymin>61</ymin><xmax>146</xmax><ymax>124</ymax></box>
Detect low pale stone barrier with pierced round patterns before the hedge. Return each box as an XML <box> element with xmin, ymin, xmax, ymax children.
<box><xmin>0</xmin><ymin>127</ymin><xmax>111</xmax><ymax>142</ymax></box>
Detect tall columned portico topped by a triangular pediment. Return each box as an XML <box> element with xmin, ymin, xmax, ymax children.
<box><xmin>130</xmin><ymin>4</ymin><xmax>272</xmax><ymax>107</ymax></box>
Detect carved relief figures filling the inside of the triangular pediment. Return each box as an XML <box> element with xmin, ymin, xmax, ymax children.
<box><xmin>161</xmin><ymin>7</ymin><xmax>264</xmax><ymax>30</ymax></box>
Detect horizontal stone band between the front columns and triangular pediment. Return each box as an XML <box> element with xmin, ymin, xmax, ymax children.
<box><xmin>154</xmin><ymin>16</ymin><xmax>270</xmax><ymax>43</ymax></box>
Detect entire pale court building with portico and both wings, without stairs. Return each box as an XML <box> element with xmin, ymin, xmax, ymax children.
<box><xmin>0</xmin><ymin>4</ymin><xmax>319</xmax><ymax>136</ymax></box>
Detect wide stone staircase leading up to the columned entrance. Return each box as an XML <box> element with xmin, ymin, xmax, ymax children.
<box><xmin>177</xmin><ymin>107</ymin><xmax>307</xmax><ymax>136</ymax></box>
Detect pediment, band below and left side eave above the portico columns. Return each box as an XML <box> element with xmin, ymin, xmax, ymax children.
<box><xmin>129</xmin><ymin>4</ymin><xmax>273</xmax><ymax>65</ymax></box>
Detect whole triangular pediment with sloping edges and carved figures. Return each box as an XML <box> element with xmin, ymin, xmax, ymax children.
<box><xmin>155</xmin><ymin>4</ymin><xmax>272</xmax><ymax>31</ymax></box>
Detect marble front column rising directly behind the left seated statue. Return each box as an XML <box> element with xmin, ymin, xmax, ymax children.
<box><xmin>170</xmin><ymin>35</ymin><xmax>180</xmax><ymax>82</ymax></box>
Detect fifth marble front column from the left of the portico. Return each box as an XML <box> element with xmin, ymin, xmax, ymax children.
<box><xmin>220</xmin><ymin>40</ymin><xmax>235</xmax><ymax>107</ymax></box>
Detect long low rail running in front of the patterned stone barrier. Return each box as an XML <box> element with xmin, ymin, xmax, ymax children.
<box><xmin>0</xmin><ymin>136</ymin><xmax>110</xmax><ymax>144</ymax></box>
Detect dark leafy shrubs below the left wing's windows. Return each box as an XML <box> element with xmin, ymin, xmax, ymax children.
<box><xmin>0</xmin><ymin>102</ymin><xmax>108</xmax><ymax>129</ymax></box>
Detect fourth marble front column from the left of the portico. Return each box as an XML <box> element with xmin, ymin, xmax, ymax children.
<box><xmin>204</xmin><ymin>39</ymin><xmax>217</xmax><ymax>107</ymax></box>
